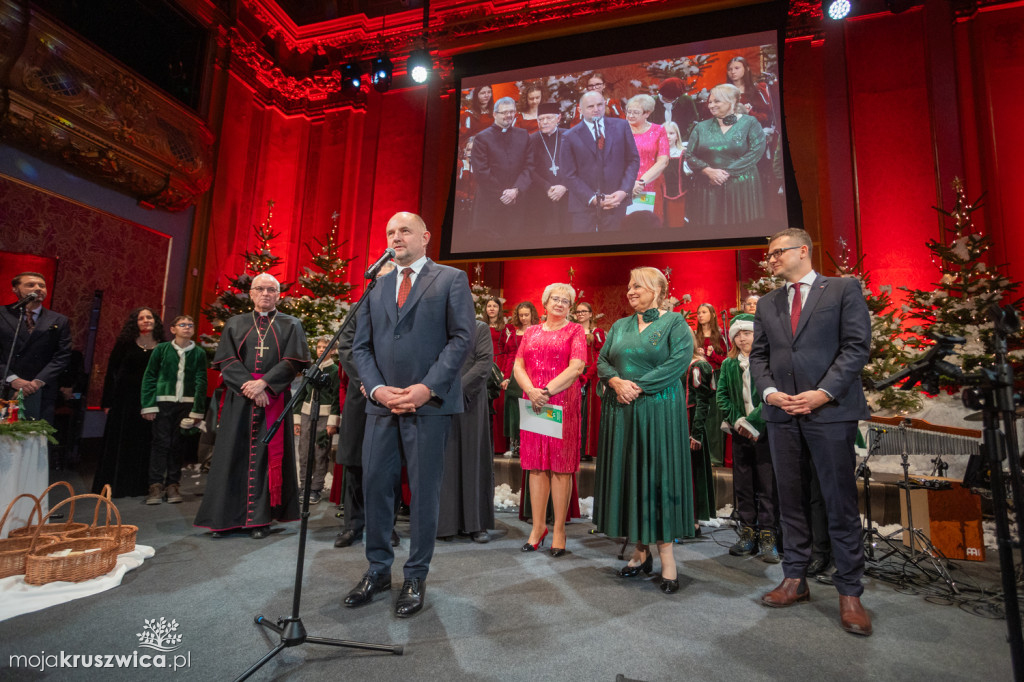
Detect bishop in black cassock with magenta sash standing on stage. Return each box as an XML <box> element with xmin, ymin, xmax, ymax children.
<box><xmin>195</xmin><ymin>274</ymin><xmax>309</xmax><ymax>538</ymax></box>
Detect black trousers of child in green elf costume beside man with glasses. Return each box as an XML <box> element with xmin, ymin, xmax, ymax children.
<box><xmin>732</xmin><ymin>431</ymin><xmax>778</xmax><ymax>530</ymax></box>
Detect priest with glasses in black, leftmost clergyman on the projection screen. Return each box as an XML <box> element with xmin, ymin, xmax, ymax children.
<box><xmin>471</xmin><ymin>97</ymin><xmax>530</xmax><ymax>244</ymax></box>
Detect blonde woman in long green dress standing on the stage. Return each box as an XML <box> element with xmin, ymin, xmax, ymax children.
<box><xmin>594</xmin><ymin>267</ymin><xmax>694</xmax><ymax>594</ymax></box>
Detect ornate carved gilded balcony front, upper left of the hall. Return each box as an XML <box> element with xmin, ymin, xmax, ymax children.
<box><xmin>0</xmin><ymin>3</ymin><xmax>213</xmax><ymax>211</ymax></box>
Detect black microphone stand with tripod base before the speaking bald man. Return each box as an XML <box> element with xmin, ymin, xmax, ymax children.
<box><xmin>236</xmin><ymin>270</ymin><xmax>402</xmax><ymax>682</ymax></box>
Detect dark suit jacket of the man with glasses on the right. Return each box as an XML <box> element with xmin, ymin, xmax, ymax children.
<box><xmin>751</xmin><ymin>274</ymin><xmax>871</xmax><ymax>423</ymax></box>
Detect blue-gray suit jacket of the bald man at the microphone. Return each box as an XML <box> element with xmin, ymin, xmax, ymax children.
<box><xmin>352</xmin><ymin>260</ymin><xmax>476</xmax><ymax>416</ymax></box>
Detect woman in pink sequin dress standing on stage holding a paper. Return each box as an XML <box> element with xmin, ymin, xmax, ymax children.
<box><xmin>513</xmin><ymin>284</ymin><xmax>587</xmax><ymax>556</ymax></box>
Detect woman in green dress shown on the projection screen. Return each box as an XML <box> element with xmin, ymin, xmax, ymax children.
<box><xmin>686</xmin><ymin>84</ymin><xmax>765</xmax><ymax>225</ymax></box>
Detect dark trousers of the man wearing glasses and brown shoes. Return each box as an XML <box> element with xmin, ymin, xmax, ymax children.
<box><xmin>768</xmin><ymin>417</ymin><xmax>864</xmax><ymax>597</ymax></box>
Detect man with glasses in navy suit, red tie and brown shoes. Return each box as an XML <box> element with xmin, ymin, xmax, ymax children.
<box><xmin>751</xmin><ymin>227</ymin><xmax>871</xmax><ymax>635</ymax></box>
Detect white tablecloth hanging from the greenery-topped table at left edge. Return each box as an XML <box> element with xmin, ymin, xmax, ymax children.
<box><xmin>0</xmin><ymin>435</ymin><xmax>50</xmax><ymax>538</ymax></box>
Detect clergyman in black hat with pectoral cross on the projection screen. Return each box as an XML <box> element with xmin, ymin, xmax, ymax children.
<box><xmin>524</xmin><ymin>102</ymin><xmax>571</xmax><ymax>237</ymax></box>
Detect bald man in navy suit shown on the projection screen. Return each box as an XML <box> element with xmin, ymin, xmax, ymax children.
<box><xmin>564</xmin><ymin>90</ymin><xmax>640</xmax><ymax>233</ymax></box>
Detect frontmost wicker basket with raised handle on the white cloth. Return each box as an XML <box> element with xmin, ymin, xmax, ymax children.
<box><xmin>25</xmin><ymin>495</ymin><xmax>121</xmax><ymax>585</ymax></box>
